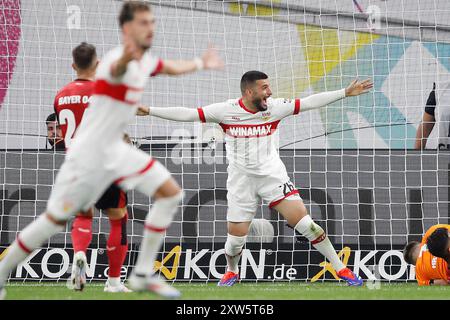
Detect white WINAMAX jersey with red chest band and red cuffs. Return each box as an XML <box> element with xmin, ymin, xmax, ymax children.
<box><xmin>197</xmin><ymin>98</ymin><xmax>300</xmax><ymax>176</ymax></box>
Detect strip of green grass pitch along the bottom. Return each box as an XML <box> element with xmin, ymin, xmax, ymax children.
<box><xmin>6</xmin><ymin>282</ymin><xmax>450</xmax><ymax>300</ymax></box>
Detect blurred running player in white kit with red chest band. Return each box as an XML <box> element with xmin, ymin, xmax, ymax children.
<box><xmin>0</xmin><ymin>1</ymin><xmax>223</xmax><ymax>298</ymax></box>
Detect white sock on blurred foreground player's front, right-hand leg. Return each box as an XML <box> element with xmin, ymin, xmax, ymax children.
<box><xmin>134</xmin><ymin>192</ymin><xmax>183</xmax><ymax>275</ymax></box>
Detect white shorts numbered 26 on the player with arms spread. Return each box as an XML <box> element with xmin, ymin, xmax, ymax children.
<box><xmin>227</xmin><ymin>168</ymin><xmax>302</xmax><ymax>222</ymax></box>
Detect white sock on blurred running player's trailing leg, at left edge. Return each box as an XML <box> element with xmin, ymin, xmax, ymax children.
<box><xmin>0</xmin><ymin>213</ymin><xmax>65</xmax><ymax>286</ymax></box>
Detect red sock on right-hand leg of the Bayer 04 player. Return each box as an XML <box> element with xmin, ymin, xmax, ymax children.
<box><xmin>106</xmin><ymin>213</ymin><xmax>128</xmax><ymax>278</ymax></box>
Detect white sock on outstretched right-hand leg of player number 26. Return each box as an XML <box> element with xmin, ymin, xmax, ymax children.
<box><xmin>295</xmin><ymin>215</ymin><xmax>345</xmax><ymax>271</ymax></box>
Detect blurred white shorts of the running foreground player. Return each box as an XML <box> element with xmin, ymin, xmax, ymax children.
<box><xmin>47</xmin><ymin>143</ymin><xmax>170</xmax><ymax>220</ymax></box>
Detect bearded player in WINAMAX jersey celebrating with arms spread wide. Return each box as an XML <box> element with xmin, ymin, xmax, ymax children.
<box><xmin>145</xmin><ymin>71</ymin><xmax>373</xmax><ymax>286</ymax></box>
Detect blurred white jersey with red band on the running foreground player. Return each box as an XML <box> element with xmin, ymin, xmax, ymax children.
<box><xmin>67</xmin><ymin>46</ymin><xmax>163</xmax><ymax>165</ymax></box>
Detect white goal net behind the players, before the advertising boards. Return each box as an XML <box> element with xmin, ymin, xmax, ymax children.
<box><xmin>0</xmin><ymin>0</ymin><xmax>450</xmax><ymax>281</ymax></box>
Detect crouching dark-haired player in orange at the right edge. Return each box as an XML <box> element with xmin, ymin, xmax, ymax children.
<box><xmin>403</xmin><ymin>224</ymin><xmax>450</xmax><ymax>286</ymax></box>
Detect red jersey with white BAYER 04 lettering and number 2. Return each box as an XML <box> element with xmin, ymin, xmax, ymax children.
<box><xmin>54</xmin><ymin>79</ymin><xmax>95</xmax><ymax>148</ymax></box>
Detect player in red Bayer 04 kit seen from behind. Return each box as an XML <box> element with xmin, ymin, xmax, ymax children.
<box><xmin>54</xmin><ymin>42</ymin><xmax>138</xmax><ymax>292</ymax></box>
